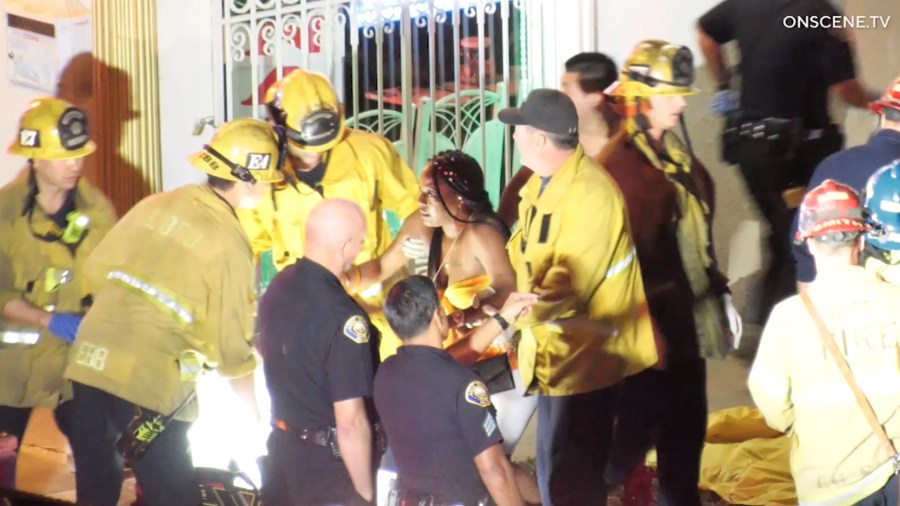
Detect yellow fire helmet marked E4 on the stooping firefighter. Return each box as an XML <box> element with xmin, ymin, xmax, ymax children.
<box><xmin>188</xmin><ymin>118</ymin><xmax>284</xmax><ymax>183</ymax></box>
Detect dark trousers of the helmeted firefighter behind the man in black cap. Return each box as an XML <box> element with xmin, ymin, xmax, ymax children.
<box><xmin>606</xmin><ymin>358</ymin><xmax>707</xmax><ymax>506</ymax></box>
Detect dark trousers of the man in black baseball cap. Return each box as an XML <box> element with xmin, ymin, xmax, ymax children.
<box><xmin>535</xmin><ymin>388</ymin><xmax>615</xmax><ymax>506</ymax></box>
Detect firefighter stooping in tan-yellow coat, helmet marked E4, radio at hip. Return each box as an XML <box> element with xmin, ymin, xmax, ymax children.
<box><xmin>66</xmin><ymin>119</ymin><xmax>282</xmax><ymax>506</ymax></box>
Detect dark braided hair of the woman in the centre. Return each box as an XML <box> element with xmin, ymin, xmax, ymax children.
<box><xmin>428</xmin><ymin>150</ymin><xmax>510</xmax><ymax>276</ymax></box>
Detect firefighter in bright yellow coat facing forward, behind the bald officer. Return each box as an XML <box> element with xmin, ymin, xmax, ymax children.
<box><xmin>238</xmin><ymin>70</ymin><xmax>419</xmax><ymax>359</ymax></box>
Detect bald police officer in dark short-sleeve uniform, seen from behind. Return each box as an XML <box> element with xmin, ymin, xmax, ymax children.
<box><xmin>259</xmin><ymin>199</ymin><xmax>380</xmax><ymax>506</ymax></box>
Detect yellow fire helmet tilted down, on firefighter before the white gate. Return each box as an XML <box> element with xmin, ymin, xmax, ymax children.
<box><xmin>273</xmin><ymin>69</ymin><xmax>344</xmax><ymax>153</ymax></box>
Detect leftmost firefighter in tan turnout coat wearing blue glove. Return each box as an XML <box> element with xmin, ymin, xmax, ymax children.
<box><xmin>0</xmin><ymin>98</ymin><xmax>116</xmax><ymax>487</ymax></box>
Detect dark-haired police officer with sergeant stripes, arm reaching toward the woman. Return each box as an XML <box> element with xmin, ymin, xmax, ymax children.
<box><xmin>375</xmin><ymin>276</ymin><xmax>537</xmax><ymax>506</ymax></box>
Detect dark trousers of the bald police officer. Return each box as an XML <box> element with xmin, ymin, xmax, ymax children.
<box><xmin>262</xmin><ymin>429</ymin><xmax>368</xmax><ymax>506</ymax></box>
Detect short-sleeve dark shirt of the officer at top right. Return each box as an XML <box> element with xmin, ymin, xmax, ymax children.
<box><xmin>700</xmin><ymin>0</ymin><xmax>856</xmax><ymax>130</ymax></box>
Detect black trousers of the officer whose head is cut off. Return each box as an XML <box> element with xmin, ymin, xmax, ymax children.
<box><xmin>738</xmin><ymin>138</ymin><xmax>842</xmax><ymax>324</ymax></box>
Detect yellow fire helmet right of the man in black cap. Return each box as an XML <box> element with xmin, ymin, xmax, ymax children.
<box><xmin>607</xmin><ymin>40</ymin><xmax>699</xmax><ymax>97</ymax></box>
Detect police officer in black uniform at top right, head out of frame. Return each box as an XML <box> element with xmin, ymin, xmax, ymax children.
<box><xmin>698</xmin><ymin>0</ymin><xmax>869</xmax><ymax>321</ymax></box>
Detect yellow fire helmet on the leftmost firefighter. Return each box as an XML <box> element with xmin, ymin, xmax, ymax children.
<box><xmin>7</xmin><ymin>97</ymin><xmax>97</xmax><ymax>160</ymax></box>
